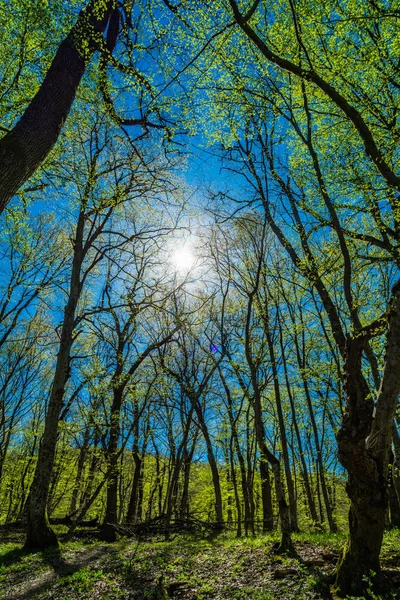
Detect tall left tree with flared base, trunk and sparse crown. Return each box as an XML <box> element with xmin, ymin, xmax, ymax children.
<box><xmin>25</xmin><ymin>115</ymin><xmax>178</xmax><ymax>549</ymax></box>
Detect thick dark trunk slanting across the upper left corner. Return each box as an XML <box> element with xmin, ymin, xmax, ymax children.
<box><xmin>0</xmin><ymin>0</ymin><xmax>116</xmax><ymax>212</ymax></box>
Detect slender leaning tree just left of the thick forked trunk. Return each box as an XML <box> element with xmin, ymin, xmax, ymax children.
<box><xmin>214</xmin><ymin>213</ymin><xmax>298</xmax><ymax>552</ymax></box>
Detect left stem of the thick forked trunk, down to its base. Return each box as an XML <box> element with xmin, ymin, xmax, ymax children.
<box><xmin>336</xmin><ymin>364</ymin><xmax>378</xmax><ymax>595</ymax></box>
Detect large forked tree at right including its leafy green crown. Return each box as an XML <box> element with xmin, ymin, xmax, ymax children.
<box><xmin>159</xmin><ymin>0</ymin><xmax>400</xmax><ymax>594</ymax></box>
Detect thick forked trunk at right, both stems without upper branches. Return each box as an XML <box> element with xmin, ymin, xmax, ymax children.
<box><xmin>336</xmin><ymin>282</ymin><xmax>400</xmax><ymax>594</ymax></box>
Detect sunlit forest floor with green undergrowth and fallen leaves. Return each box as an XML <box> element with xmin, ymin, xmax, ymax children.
<box><xmin>0</xmin><ymin>530</ymin><xmax>400</xmax><ymax>600</ymax></box>
